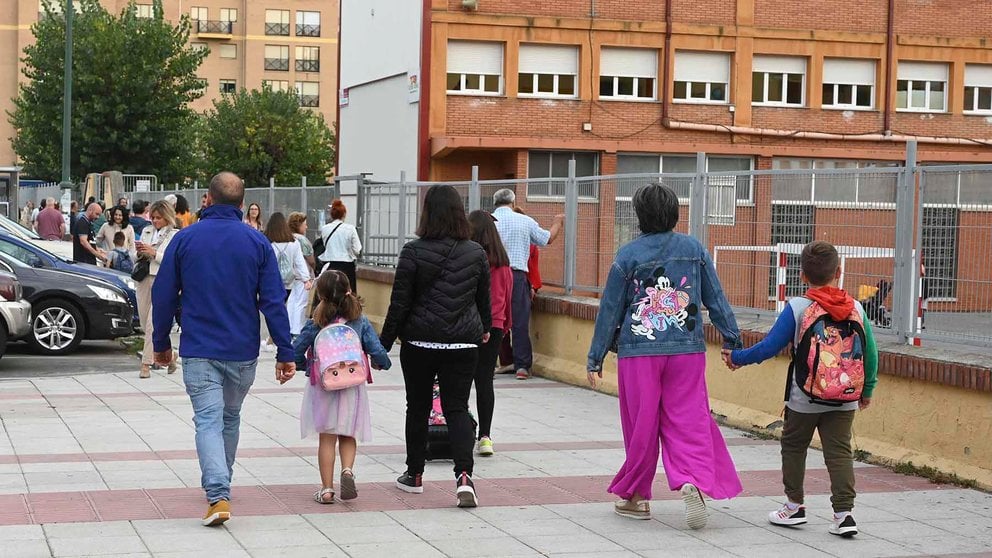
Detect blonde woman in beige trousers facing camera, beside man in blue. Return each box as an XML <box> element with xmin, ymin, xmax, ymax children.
<box><xmin>132</xmin><ymin>200</ymin><xmax>176</xmax><ymax>378</ymax></box>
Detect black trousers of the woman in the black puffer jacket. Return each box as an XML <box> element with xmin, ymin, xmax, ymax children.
<box><xmin>400</xmin><ymin>343</ymin><xmax>479</xmax><ymax>476</ymax></box>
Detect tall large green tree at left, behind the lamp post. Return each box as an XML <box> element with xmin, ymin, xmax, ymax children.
<box><xmin>8</xmin><ymin>0</ymin><xmax>207</xmax><ymax>181</ymax></box>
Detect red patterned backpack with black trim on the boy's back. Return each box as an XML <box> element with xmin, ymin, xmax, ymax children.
<box><xmin>785</xmin><ymin>301</ymin><xmax>867</xmax><ymax>406</ymax></box>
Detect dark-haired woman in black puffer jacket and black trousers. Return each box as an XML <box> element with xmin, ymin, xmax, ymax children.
<box><xmin>379</xmin><ymin>186</ymin><xmax>492</xmax><ymax>507</ymax></box>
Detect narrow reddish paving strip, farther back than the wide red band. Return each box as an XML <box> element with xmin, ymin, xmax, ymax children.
<box><xmin>0</xmin><ymin>438</ymin><xmax>778</xmax><ymax>465</ymax></box>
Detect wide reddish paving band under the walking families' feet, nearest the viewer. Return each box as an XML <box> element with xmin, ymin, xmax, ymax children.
<box><xmin>0</xmin><ymin>467</ymin><xmax>954</xmax><ymax>525</ymax></box>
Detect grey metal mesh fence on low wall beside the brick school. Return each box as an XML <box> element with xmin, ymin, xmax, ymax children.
<box><xmin>357</xmin><ymin>149</ymin><xmax>992</xmax><ymax>346</ymax></box>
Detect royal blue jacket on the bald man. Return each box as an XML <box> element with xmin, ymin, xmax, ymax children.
<box><xmin>152</xmin><ymin>205</ymin><xmax>293</xmax><ymax>362</ymax></box>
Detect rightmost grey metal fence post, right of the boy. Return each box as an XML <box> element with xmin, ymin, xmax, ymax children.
<box><xmin>892</xmin><ymin>141</ymin><xmax>916</xmax><ymax>343</ymax></box>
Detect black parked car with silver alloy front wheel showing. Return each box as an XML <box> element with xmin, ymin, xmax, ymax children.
<box><xmin>0</xmin><ymin>253</ymin><xmax>133</xmax><ymax>355</ymax></box>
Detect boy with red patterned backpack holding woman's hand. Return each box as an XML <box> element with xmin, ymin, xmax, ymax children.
<box><xmin>723</xmin><ymin>240</ymin><xmax>878</xmax><ymax>538</ymax></box>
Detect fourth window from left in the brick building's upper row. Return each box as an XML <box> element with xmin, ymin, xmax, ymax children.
<box><xmin>672</xmin><ymin>51</ymin><xmax>730</xmax><ymax>104</ymax></box>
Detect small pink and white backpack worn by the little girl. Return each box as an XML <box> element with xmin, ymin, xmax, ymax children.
<box><xmin>310</xmin><ymin>321</ymin><xmax>371</xmax><ymax>391</ymax></box>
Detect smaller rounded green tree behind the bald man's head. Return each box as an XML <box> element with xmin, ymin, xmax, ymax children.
<box><xmin>200</xmin><ymin>86</ymin><xmax>335</xmax><ymax>186</ymax></box>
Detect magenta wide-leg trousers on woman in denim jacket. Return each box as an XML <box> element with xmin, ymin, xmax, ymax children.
<box><xmin>609</xmin><ymin>353</ymin><xmax>742</xmax><ymax>500</ymax></box>
